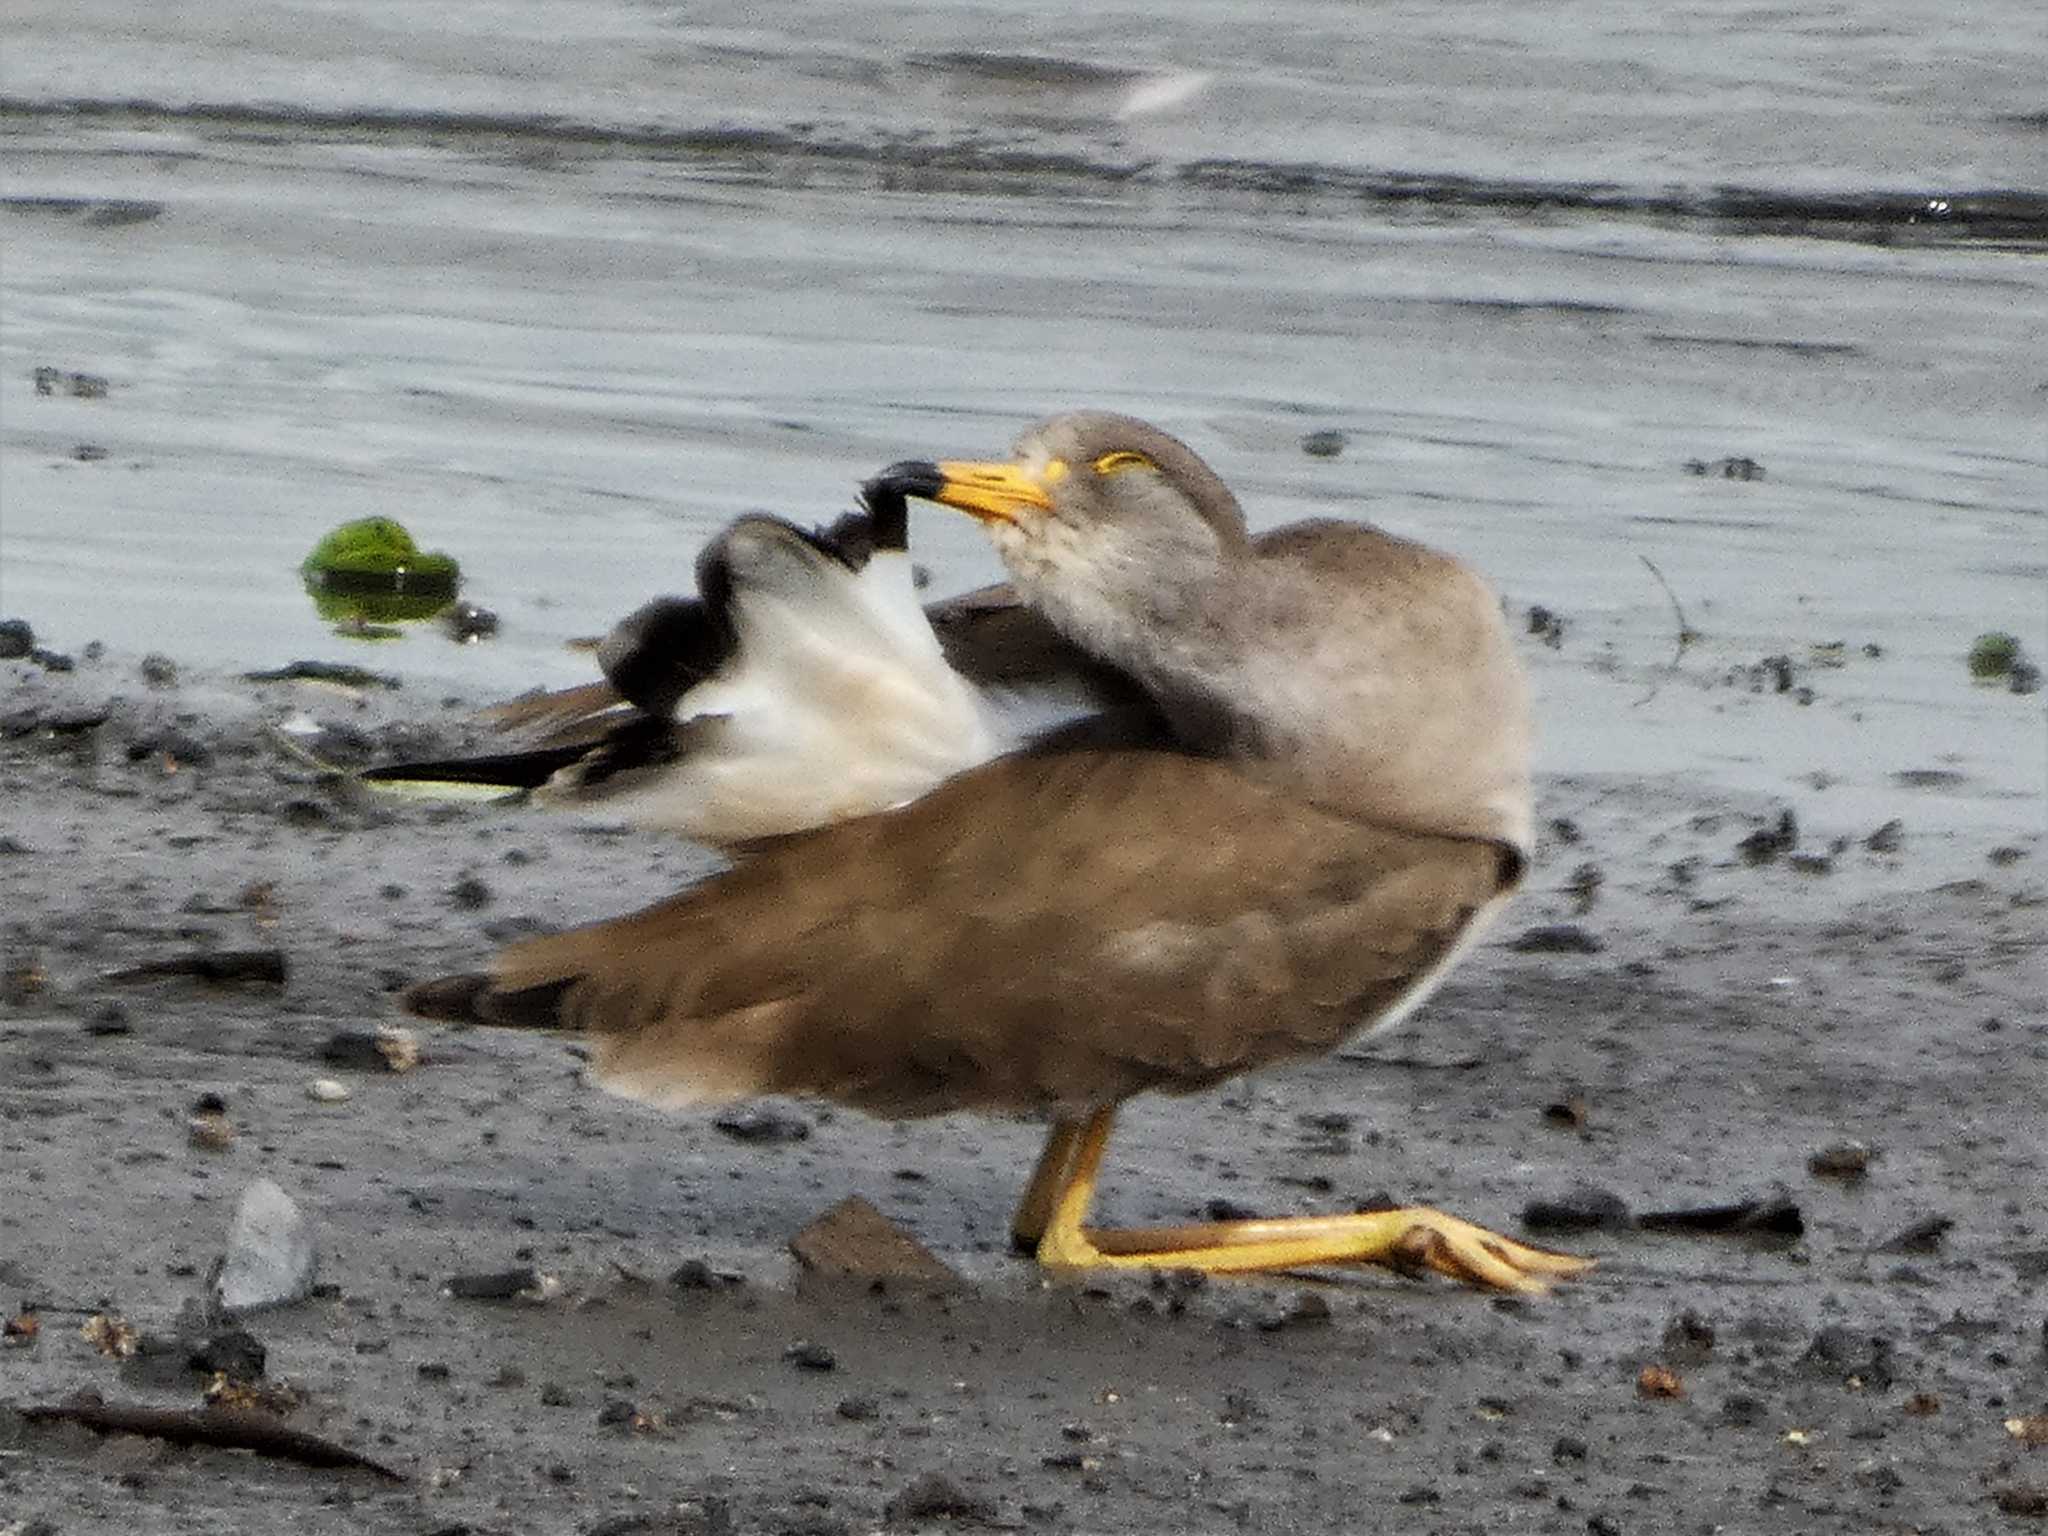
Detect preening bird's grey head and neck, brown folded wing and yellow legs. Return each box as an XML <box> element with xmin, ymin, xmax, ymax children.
<box><xmin>414</xmin><ymin>414</ymin><xmax>1575</xmax><ymax>1284</ymax></box>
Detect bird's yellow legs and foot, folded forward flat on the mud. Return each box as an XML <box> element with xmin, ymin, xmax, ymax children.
<box><xmin>1018</xmin><ymin>1110</ymin><xmax>1591</xmax><ymax>1292</ymax></box>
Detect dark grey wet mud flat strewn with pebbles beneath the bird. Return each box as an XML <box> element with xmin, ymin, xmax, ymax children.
<box><xmin>0</xmin><ymin>651</ymin><xmax>2048</xmax><ymax>1536</ymax></box>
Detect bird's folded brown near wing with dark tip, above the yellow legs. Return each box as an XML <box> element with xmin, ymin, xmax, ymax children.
<box><xmin>444</xmin><ymin>750</ymin><xmax>1513</xmax><ymax>1116</ymax></box>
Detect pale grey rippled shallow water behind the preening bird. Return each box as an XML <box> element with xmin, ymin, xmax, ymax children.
<box><xmin>0</xmin><ymin>4</ymin><xmax>2048</xmax><ymax>825</ymax></box>
